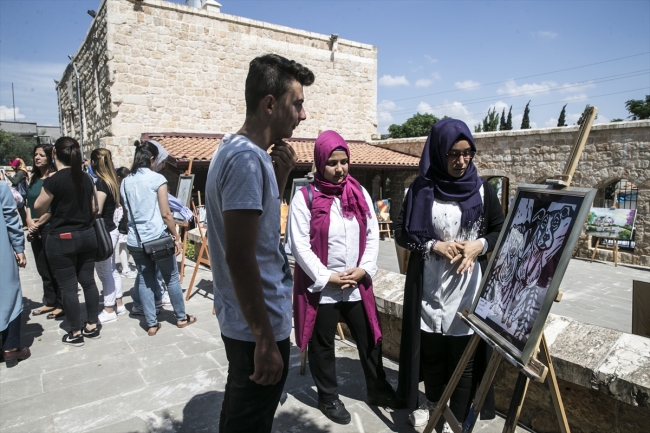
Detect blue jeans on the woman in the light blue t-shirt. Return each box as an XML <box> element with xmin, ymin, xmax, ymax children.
<box><xmin>129</xmin><ymin>247</ymin><xmax>185</xmax><ymax>328</ymax></box>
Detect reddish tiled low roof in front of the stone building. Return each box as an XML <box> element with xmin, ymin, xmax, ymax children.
<box><xmin>142</xmin><ymin>132</ymin><xmax>420</xmax><ymax>170</ymax></box>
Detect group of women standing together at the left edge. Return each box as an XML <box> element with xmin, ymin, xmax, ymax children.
<box><xmin>0</xmin><ymin>137</ymin><xmax>196</xmax><ymax>366</ymax></box>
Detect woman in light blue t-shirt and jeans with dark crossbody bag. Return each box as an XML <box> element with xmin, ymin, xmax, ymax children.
<box><xmin>120</xmin><ymin>141</ymin><xmax>196</xmax><ymax>336</ymax></box>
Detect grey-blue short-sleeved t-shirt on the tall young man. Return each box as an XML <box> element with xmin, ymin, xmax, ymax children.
<box><xmin>205</xmin><ymin>134</ymin><xmax>292</xmax><ymax>341</ymax></box>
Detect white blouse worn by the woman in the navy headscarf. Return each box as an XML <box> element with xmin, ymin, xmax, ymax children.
<box><xmin>420</xmin><ymin>187</ymin><xmax>487</xmax><ymax>336</ymax></box>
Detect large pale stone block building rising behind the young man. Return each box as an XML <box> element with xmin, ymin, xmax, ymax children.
<box><xmin>57</xmin><ymin>0</ymin><xmax>377</xmax><ymax>165</ymax></box>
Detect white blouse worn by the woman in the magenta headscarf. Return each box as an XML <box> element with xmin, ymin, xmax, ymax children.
<box><xmin>289</xmin><ymin>185</ymin><xmax>379</xmax><ymax>304</ymax></box>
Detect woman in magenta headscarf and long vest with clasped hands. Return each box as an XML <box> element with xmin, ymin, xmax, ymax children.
<box><xmin>289</xmin><ymin>131</ymin><xmax>403</xmax><ymax>424</ymax></box>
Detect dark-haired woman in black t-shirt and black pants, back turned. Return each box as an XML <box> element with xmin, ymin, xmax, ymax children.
<box><xmin>34</xmin><ymin>137</ymin><xmax>101</xmax><ymax>346</ymax></box>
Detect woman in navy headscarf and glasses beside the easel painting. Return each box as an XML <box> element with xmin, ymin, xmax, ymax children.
<box><xmin>395</xmin><ymin>118</ymin><xmax>504</xmax><ymax>431</ymax></box>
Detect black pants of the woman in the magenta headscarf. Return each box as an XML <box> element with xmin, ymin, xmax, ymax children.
<box><xmin>307</xmin><ymin>301</ymin><xmax>394</xmax><ymax>403</ymax></box>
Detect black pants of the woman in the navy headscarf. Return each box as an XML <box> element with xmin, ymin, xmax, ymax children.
<box><xmin>420</xmin><ymin>331</ymin><xmax>474</xmax><ymax>423</ymax></box>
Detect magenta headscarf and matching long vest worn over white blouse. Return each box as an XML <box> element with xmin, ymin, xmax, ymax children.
<box><xmin>293</xmin><ymin>131</ymin><xmax>382</xmax><ymax>350</ymax></box>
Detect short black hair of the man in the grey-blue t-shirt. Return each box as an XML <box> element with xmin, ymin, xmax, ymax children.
<box><xmin>245</xmin><ymin>54</ymin><xmax>314</xmax><ymax>115</ymax></box>
